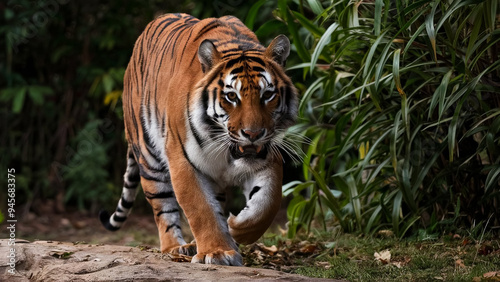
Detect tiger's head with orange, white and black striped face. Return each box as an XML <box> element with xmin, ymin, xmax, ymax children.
<box><xmin>192</xmin><ymin>35</ymin><xmax>298</xmax><ymax>162</ymax></box>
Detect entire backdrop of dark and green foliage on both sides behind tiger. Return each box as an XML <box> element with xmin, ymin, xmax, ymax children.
<box><xmin>0</xmin><ymin>0</ymin><xmax>500</xmax><ymax>236</ymax></box>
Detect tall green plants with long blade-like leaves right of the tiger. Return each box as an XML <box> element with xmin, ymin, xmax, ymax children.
<box><xmin>275</xmin><ymin>0</ymin><xmax>500</xmax><ymax>236</ymax></box>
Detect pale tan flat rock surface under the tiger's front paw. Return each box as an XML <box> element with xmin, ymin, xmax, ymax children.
<box><xmin>0</xmin><ymin>239</ymin><xmax>340</xmax><ymax>281</ymax></box>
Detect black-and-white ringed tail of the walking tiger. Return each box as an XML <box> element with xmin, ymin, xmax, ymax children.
<box><xmin>99</xmin><ymin>146</ymin><xmax>141</xmax><ymax>231</ymax></box>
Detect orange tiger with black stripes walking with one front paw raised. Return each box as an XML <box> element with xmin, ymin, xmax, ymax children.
<box><xmin>99</xmin><ymin>14</ymin><xmax>298</xmax><ymax>266</ymax></box>
